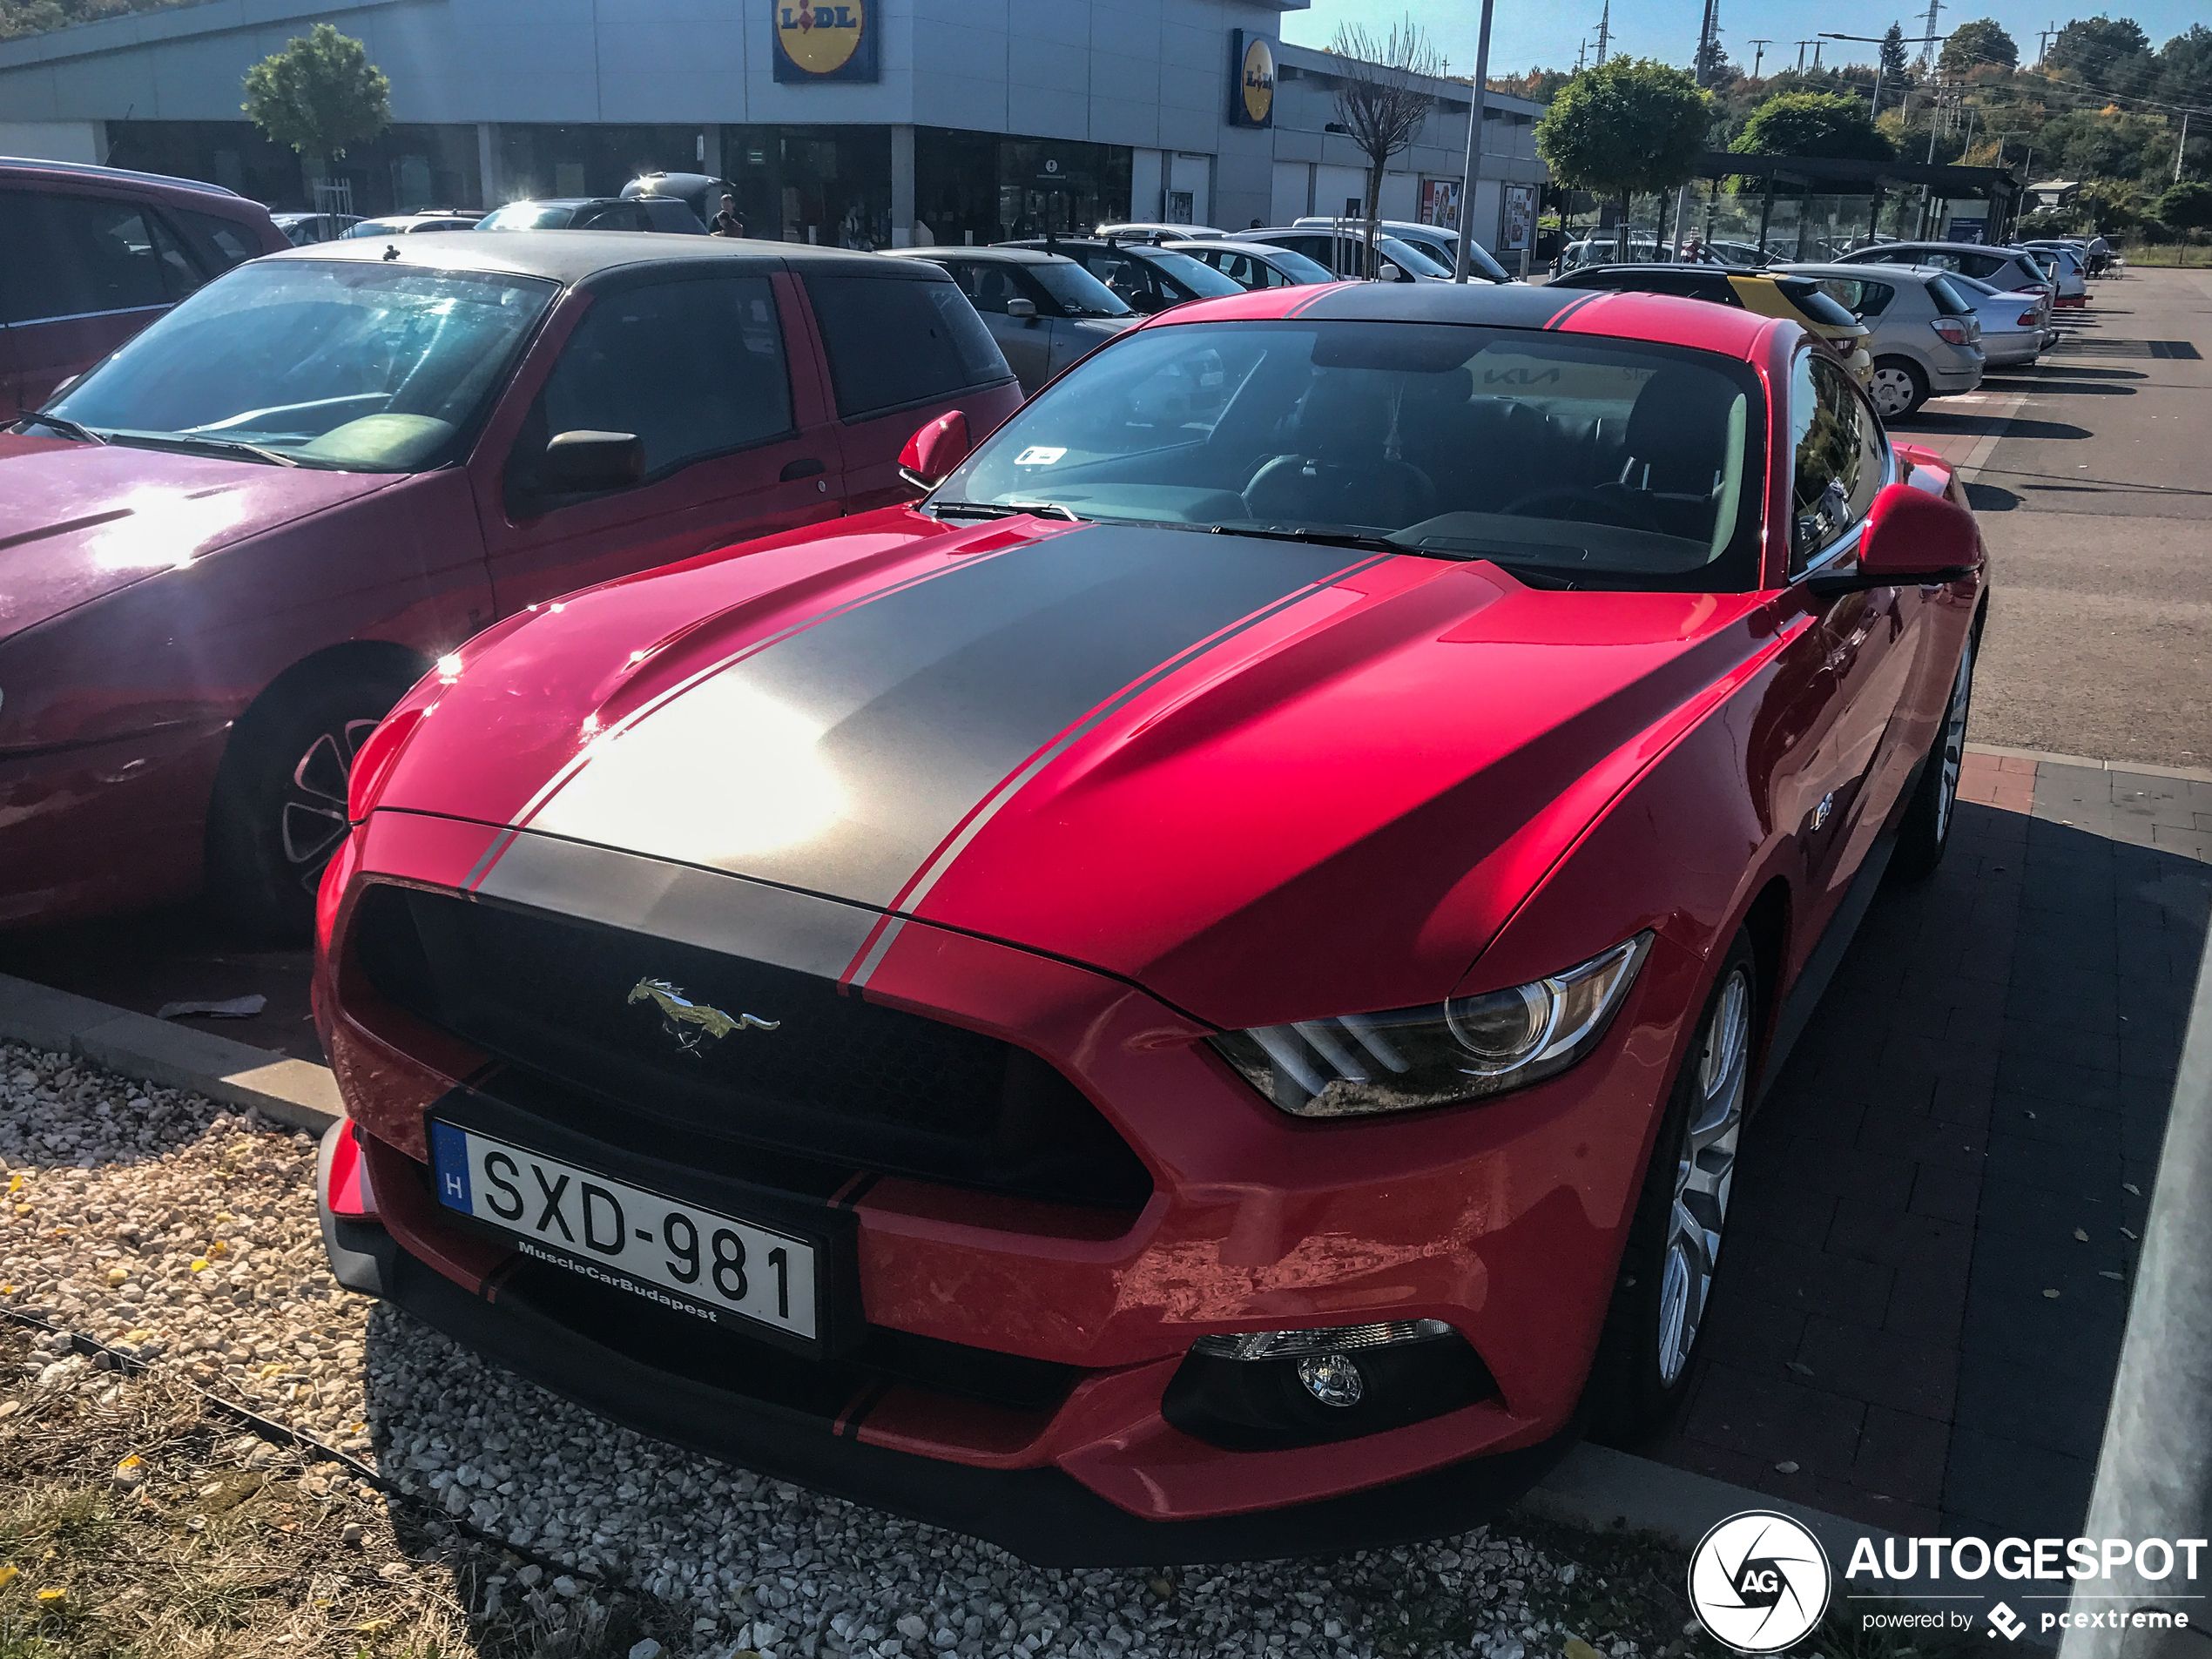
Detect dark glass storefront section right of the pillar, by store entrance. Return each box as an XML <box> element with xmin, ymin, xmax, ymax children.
<box><xmin>914</xmin><ymin>126</ymin><xmax>1132</xmax><ymax>243</ymax></box>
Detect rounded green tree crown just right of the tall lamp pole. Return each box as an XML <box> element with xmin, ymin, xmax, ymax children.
<box><xmin>1535</xmin><ymin>57</ymin><xmax>1712</xmax><ymax>231</ymax></box>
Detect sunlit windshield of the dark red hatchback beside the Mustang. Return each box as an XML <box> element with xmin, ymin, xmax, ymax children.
<box><xmin>49</xmin><ymin>259</ymin><xmax>560</xmax><ymax>474</ymax></box>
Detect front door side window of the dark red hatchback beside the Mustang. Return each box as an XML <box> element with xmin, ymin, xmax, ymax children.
<box><xmin>517</xmin><ymin>277</ymin><xmax>792</xmax><ymax>478</ymax></box>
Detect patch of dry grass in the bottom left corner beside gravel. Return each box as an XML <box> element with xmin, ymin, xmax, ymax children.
<box><xmin>0</xmin><ymin>1325</ymin><xmax>688</xmax><ymax>1659</ymax></box>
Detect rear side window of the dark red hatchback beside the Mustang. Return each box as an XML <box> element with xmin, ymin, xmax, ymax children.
<box><xmin>807</xmin><ymin>261</ymin><xmax>1017</xmax><ymax>418</ymax></box>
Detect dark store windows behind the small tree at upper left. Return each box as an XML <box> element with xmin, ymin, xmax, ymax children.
<box><xmin>106</xmin><ymin>122</ymin><xmax>482</xmax><ymax>214</ymax></box>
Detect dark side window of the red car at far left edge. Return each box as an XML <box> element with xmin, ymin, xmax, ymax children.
<box><xmin>0</xmin><ymin>190</ymin><xmax>174</xmax><ymax>323</ymax></box>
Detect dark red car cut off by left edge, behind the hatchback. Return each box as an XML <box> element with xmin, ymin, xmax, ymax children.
<box><xmin>0</xmin><ymin>157</ymin><xmax>292</xmax><ymax>421</ymax></box>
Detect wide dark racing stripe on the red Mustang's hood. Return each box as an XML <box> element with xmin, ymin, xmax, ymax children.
<box><xmin>513</xmin><ymin>524</ymin><xmax>1378</xmax><ymax>942</ymax></box>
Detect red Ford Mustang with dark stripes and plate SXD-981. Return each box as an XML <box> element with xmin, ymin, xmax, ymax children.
<box><xmin>316</xmin><ymin>283</ymin><xmax>1986</xmax><ymax>1561</ymax></box>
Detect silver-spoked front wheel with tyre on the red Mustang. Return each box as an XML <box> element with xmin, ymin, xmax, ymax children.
<box><xmin>1588</xmin><ymin>934</ymin><xmax>1758</xmax><ymax>1447</ymax></box>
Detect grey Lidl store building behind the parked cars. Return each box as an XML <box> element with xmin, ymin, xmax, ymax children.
<box><xmin>0</xmin><ymin>0</ymin><xmax>1544</xmax><ymax>250</ymax></box>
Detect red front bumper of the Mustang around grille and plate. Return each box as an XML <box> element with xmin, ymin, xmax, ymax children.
<box><xmin>316</xmin><ymin>814</ymin><xmax>1699</xmax><ymax>1561</ymax></box>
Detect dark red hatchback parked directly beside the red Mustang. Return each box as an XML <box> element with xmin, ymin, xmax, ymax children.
<box><xmin>0</xmin><ymin>233</ymin><xmax>1020</xmax><ymax>934</ymax></box>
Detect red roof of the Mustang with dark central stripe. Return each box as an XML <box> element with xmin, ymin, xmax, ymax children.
<box><xmin>1139</xmin><ymin>283</ymin><xmax>1778</xmax><ymax>361</ymax></box>
